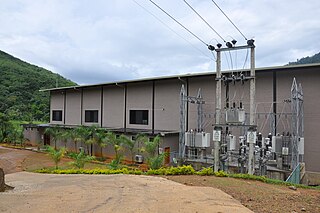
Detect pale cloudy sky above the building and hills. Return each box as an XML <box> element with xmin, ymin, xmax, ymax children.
<box><xmin>0</xmin><ymin>0</ymin><xmax>320</xmax><ymax>85</ymax></box>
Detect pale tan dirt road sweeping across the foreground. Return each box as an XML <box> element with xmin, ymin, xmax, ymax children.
<box><xmin>0</xmin><ymin>148</ymin><xmax>251</xmax><ymax>213</ymax></box>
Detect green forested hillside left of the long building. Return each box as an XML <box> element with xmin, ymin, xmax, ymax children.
<box><xmin>0</xmin><ymin>51</ymin><xmax>76</xmax><ymax>122</ymax></box>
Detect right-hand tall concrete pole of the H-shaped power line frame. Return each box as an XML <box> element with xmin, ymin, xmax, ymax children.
<box><xmin>248</xmin><ymin>46</ymin><xmax>256</xmax><ymax>175</ymax></box>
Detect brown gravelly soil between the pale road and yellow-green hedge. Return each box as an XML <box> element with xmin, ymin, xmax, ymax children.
<box><xmin>166</xmin><ymin>176</ymin><xmax>320</xmax><ymax>213</ymax></box>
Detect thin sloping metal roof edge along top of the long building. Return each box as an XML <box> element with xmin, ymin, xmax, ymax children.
<box><xmin>39</xmin><ymin>63</ymin><xmax>320</xmax><ymax>92</ymax></box>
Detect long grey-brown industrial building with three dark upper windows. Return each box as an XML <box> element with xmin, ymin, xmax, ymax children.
<box><xmin>25</xmin><ymin>64</ymin><xmax>320</xmax><ymax>184</ymax></box>
